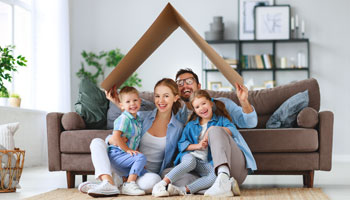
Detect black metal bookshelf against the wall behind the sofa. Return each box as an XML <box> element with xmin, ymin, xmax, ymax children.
<box><xmin>202</xmin><ymin>39</ymin><xmax>310</xmax><ymax>89</ymax></box>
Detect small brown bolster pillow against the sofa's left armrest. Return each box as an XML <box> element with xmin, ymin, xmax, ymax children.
<box><xmin>61</xmin><ymin>112</ymin><xmax>86</xmax><ymax>131</ymax></box>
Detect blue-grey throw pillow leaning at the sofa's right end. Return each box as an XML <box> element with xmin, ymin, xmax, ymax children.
<box><xmin>266</xmin><ymin>90</ymin><xmax>309</xmax><ymax>128</ymax></box>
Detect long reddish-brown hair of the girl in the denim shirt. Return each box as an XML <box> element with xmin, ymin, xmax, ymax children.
<box><xmin>188</xmin><ymin>90</ymin><xmax>232</xmax><ymax>121</ymax></box>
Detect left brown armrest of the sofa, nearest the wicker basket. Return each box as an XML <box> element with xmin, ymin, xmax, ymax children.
<box><xmin>46</xmin><ymin>112</ymin><xmax>63</xmax><ymax>171</ymax></box>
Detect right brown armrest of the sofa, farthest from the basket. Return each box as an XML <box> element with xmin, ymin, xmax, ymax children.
<box><xmin>318</xmin><ymin>111</ymin><xmax>334</xmax><ymax>171</ymax></box>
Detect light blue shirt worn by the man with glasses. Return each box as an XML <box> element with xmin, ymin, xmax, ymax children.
<box><xmin>176</xmin><ymin>97</ymin><xmax>258</xmax><ymax>171</ymax></box>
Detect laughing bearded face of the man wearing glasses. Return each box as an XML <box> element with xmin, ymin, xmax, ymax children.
<box><xmin>176</xmin><ymin>73</ymin><xmax>201</xmax><ymax>102</ymax></box>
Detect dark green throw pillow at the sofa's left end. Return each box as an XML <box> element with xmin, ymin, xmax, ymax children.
<box><xmin>75</xmin><ymin>79</ymin><xmax>108</xmax><ymax>129</ymax></box>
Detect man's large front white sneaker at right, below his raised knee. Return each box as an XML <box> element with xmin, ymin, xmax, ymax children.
<box><xmin>204</xmin><ymin>173</ymin><xmax>233</xmax><ymax>197</ymax></box>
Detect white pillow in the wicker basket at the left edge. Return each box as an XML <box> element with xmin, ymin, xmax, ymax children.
<box><xmin>0</xmin><ymin>122</ymin><xmax>19</xmax><ymax>150</ymax></box>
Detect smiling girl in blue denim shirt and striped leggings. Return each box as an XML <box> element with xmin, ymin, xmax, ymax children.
<box><xmin>152</xmin><ymin>90</ymin><xmax>235</xmax><ymax>197</ymax></box>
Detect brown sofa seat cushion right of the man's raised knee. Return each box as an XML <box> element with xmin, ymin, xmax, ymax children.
<box><xmin>239</xmin><ymin>128</ymin><xmax>319</xmax><ymax>153</ymax></box>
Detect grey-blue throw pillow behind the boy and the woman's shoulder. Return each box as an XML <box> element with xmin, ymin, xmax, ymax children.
<box><xmin>107</xmin><ymin>98</ymin><xmax>156</xmax><ymax>129</ymax></box>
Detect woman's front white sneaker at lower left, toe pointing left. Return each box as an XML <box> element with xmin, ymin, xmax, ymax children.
<box><xmin>88</xmin><ymin>180</ymin><xmax>120</xmax><ymax>197</ymax></box>
